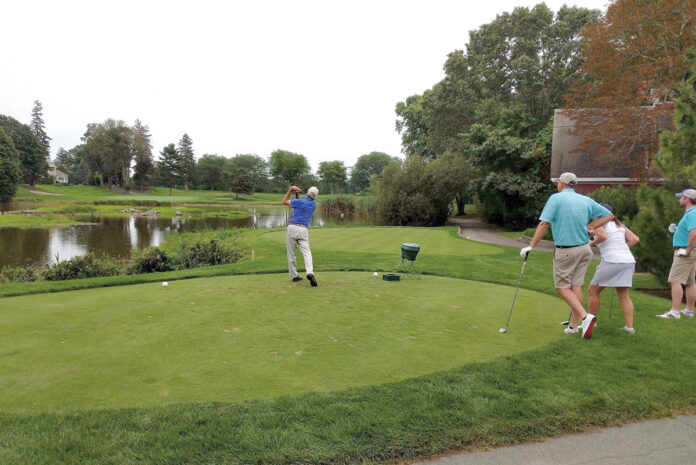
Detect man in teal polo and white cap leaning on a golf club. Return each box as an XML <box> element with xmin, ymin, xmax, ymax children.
<box><xmin>520</xmin><ymin>173</ymin><xmax>613</xmax><ymax>339</ymax></box>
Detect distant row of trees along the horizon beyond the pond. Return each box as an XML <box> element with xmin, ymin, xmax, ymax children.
<box><xmin>0</xmin><ymin>101</ymin><xmax>393</xmax><ymax>202</ymax></box>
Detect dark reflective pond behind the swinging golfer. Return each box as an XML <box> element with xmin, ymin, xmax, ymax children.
<box><xmin>0</xmin><ymin>207</ymin><xmax>370</xmax><ymax>267</ymax></box>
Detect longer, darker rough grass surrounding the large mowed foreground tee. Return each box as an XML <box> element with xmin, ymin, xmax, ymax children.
<box><xmin>0</xmin><ymin>228</ymin><xmax>696</xmax><ymax>464</ymax></box>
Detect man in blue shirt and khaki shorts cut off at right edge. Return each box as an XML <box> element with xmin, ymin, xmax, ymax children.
<box><xmin>657</xmin><ymin>189</ymin><xmax>696</xmax><ymax>320</ymax></box>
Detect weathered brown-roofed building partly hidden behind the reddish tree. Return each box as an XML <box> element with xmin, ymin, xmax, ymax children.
<box><xmin>551</xmin><ymin>107</ymin><xmax>660</xmax><ymax>193</ymax></box>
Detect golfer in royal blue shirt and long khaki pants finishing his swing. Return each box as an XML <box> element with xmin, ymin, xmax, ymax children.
<box><xmin>283</xmin><ymin>186</ymin><xmax>319</xmax><ymax>287</ymax></box>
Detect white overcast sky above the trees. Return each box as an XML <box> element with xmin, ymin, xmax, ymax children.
<box><xmin>0</xmin><ymin>0</ymin><xmax>607</xmax><ymax>169</ymax></box>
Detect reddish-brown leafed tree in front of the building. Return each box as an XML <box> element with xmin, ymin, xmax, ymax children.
<box><xmin>567</xmin><ymin>0</ymin><xmax>696</xmax><ymax>177</ymax></box>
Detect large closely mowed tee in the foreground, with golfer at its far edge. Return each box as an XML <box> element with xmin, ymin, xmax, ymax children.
<box><xmin>0</xmin><ymin>272</ymin><xmax>567</xmax><ymax>413</ymax></box>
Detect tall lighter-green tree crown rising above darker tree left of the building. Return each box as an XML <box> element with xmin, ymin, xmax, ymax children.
<box><xmin>397</xmin><ymin>4</ymin><xmax>599</xmax><ymax>160</ymax></box>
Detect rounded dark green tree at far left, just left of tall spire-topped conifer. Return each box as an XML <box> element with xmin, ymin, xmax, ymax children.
<box><xmin>0</xmin><ymin>115</ymin><xmax>48</xmax><ymax>186</ymax></box>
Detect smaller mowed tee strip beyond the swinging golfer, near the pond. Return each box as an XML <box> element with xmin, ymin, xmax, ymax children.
<box><xmin>262</xmin><ymin>227</ymin><xmax>501</xmax><ymax>256</ymax></box>
